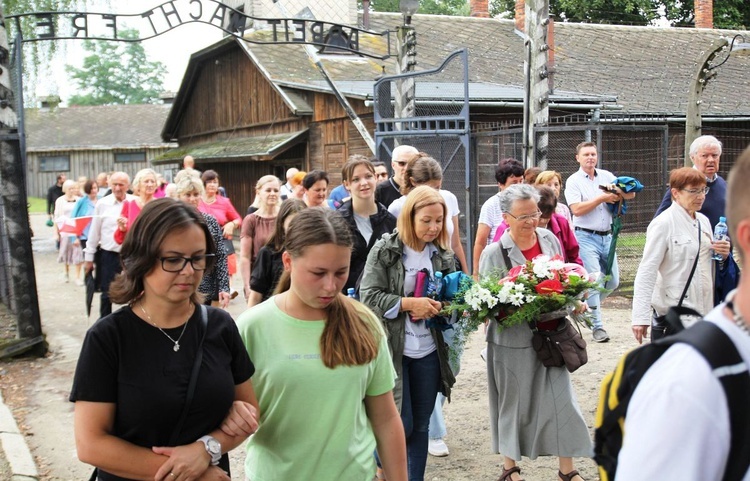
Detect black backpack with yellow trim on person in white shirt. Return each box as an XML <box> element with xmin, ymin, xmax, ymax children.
<box><xmin>594</xmin><ymin>308</ymin><xmax>750</xmax><ymax>481</ymax></box>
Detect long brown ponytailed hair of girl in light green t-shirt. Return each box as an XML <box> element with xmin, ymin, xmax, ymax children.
<box><xmin>274</xmin><ymin>207</ymin><xmax>378</xmax><ymax>369</ymax></box>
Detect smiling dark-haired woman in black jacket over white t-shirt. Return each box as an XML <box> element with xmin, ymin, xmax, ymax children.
<box><xmin>338</xmin><ymin>155</ymin><xmax>396</xmax><ymax>293</ymax></box>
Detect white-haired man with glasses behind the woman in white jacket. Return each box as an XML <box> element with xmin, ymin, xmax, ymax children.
<box><xmin>654</xmin><ymin>135</ymin><xmax>727</xmax><ymax>229</ymax></box>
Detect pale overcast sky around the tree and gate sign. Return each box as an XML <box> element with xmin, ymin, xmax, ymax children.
<box><xmin>35</xmin><ymin>0</ymin><xmax>222</xmax><ymax>107</ymax></box>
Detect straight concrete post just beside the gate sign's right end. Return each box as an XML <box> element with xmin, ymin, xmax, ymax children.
<box><xmin>395</xmin><ymin>0</ymin><xmax>419</xmax><ymax>125</ymax></box>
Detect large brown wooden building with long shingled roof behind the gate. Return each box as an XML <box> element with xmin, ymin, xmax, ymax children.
<box><xmin>155</xmin><ymin>13</ymin><xmax>750</xmax><ymax>219</ymax></box>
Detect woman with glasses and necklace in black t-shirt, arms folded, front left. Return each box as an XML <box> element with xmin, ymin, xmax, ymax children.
<box><xmin>70</xmin><ymin>198</ymin><xmax>259</xmax><ymax>481</ymax></box>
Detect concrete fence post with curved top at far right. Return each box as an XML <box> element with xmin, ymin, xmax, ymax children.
<box><xmin>685</xmin><ymin>35</ymin><xmax>750</xmax><ymax>167</ymax></box>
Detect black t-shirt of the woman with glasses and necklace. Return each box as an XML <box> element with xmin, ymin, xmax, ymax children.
<box><xmin>70</xmin><ymin>306</ymin><xmax>255</xmax><ymax>480</ymax></box>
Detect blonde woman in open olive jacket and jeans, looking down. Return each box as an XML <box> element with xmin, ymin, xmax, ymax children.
<box><xmin>360</xmin><ymin>185</ymin><xmax>456</xmax><ymax>481</ymax></box>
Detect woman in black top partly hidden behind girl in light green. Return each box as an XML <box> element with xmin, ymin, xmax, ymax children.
<box><xmin>247</xmin><ymin>199</ymin><xmax>307</xmax><ymax>307</ymax></box>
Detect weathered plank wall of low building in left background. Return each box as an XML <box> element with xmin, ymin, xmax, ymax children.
<box><xmin>26</xmin><ymin>147</ymin><xmax>169</xmax><ymax>198</ymax></box>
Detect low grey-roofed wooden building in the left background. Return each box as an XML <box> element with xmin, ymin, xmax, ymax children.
<box><xmin>24</xmin><ymin>104</ymin><xmax>176</xmax><ymax>197</ymax></box>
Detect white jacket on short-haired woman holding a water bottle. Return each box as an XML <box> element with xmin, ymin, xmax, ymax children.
<box><xmin>632</xmin><ymin>202</ymin><xmax>714</xmax><ymax>326</ymax></box>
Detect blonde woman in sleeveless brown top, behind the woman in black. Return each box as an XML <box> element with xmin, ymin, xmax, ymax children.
<box><xmin>240</xmin><ymin>175</ymin><xmax>281</xmax><ymax>300</ymax></box>
